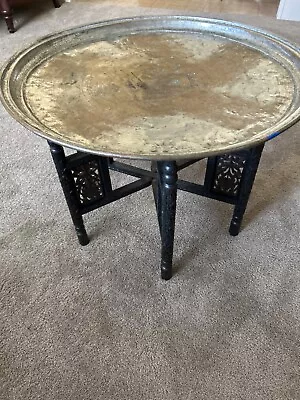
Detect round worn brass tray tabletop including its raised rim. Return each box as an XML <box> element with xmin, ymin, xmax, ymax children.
<box><xmin>0</xmin><ymin>16</ymin><xmax>300</xmax><ymax>160</ymax></box>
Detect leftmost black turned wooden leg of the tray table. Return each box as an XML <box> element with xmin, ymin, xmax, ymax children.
<box><xmin>48</xmin><ymin>141</ymin><xmax>89</xmax><ymax>246</ymax></box>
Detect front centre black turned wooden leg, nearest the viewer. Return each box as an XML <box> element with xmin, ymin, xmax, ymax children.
<box><xmin>157</xmin><ymin>161</ymin><xmax>178</xmax><ymax>280</ymax></box>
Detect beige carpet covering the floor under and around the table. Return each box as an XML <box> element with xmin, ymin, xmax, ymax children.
<box><xmin>0</xmin><ymin>2</ymin><xmax>300</xmax><ymax>400</ymax></box>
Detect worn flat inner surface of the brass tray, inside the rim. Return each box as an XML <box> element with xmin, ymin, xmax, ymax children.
<box><xmin>25</xmin><ymin>33</ymin><xmax>294</xmax><ymax>157</ymax></box>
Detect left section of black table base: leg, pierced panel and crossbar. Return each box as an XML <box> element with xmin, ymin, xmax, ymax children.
<box><xmin>48</xmin><ymin>145</ymin><xmax>152</xmax><ymax>245</ymax></box>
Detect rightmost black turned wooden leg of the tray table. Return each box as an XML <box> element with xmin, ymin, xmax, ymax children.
<box><xmin>229</xmin><ymin>143</ymin><xmax>264</xmax><ymax>236</ymax></box>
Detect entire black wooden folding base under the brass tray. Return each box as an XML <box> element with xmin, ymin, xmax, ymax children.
<box><xmin>49</xmin><ymin>142</ymin><xmax>264</xmax><ymax>280</ymax></box>
